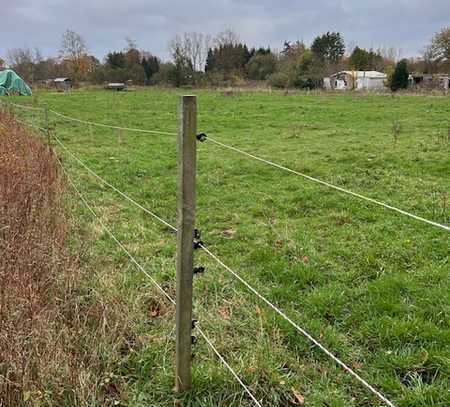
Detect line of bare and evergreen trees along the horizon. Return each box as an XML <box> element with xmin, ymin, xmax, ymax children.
<box><xmin>0</xmin><ymin>27</ymin><xmax>450</xmax><ymax>89</ymax></box>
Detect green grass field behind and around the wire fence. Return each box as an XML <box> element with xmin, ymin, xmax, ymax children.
<box><xmin>7</xmin><ymin>90</ymin><xmax>450</xmax><ymax>407</ymax></box>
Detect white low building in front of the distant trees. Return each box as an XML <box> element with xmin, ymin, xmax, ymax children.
<box><xmin>323</xmin><ymin>71</ymin><xmax>387</xmax><ymax>90</ymax></box>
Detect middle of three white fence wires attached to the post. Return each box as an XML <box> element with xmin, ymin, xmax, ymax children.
<box><xmin>46</xmin><ymin>127</ymin><xmax>395</xmax><ymax>407</ymax></box>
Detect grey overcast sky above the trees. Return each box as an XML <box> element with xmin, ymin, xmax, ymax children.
<box><xmin>0</xmin><ymin>0</ymin><xmax>450</xmax><ymax>59</ymax></box>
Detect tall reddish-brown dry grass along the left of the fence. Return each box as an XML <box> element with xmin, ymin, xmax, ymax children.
<box><xmin>0</xmin><ymin>112</ymin><xmax>132</xmax><ymax>406</ymax></box>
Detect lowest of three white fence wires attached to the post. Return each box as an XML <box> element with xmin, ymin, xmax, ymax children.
<box><xmin>56</xmin><ymin>157</ymin><xmax>262</xmax><ymax>407</ymax></box>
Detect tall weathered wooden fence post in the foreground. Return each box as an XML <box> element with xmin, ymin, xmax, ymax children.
<box><xmin>175</xmin><ymin>96</ymin><xmax>197</xmax><ymax>393</ymax></box>
